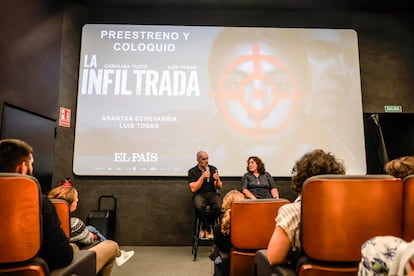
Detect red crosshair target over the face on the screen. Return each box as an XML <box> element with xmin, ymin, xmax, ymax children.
<box><xmin>211</xmin><ymin>45</ymin><xmax>303</xmax><ymax>140</ymax></box>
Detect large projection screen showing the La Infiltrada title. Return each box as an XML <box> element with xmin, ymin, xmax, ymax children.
<box><xmin>73</xmin><ymin>24</ymin><xmax>366</xmax><ymax>177</ymax></box>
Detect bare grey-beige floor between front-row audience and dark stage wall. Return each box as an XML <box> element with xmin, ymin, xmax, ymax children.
<box><xmin>111</xmin><ymin>246</ymin><xmax>214</xmax><ymax>276</ymax></box>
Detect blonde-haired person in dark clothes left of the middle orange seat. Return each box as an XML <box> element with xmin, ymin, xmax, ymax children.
<box><xmin>212</xmin><ymin>190</ymin><xmax>245</xmax><ymax>276</ymax></box>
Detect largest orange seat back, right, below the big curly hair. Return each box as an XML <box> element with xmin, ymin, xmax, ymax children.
<box><xmin>300</xmin><ymin>175</ymin><xmax>403</xmax><ymax>275</ymax></box>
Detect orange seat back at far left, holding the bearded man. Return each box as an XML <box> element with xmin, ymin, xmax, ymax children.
<box><xmin>0</xmin><ymin>173</ymin><xmax>47</xmax><ymax>275</ymax></box>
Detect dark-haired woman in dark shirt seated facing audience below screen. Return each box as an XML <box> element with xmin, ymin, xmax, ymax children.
<box><xmin>241</xmin><ymin>156</ymin><xmax>279</xmax><ymax>199</ymax></box>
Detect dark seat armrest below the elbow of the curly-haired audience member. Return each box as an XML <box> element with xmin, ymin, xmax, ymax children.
<box><xmin>253</xmin><ymin>249</ymin><xmax>296</xmax><ymax>276</ymax></box>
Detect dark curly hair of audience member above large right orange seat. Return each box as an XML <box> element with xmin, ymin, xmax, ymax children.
<box><xmin>291</xmin><ymin>149</ymin><xmax>345</xmax><ymax>194</ymax></box>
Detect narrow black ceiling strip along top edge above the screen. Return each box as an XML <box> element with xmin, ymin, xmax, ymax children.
<box><xmin>79</xmin><ymin>0</ymin><xmax>411</xmax><ymax>12</ymax></box>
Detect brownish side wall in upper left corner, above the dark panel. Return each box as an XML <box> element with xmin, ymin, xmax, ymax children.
<box><xmin>0</xmin><ymin>0</ymin><xmax>64</xmax><ymax>122</ymax></box>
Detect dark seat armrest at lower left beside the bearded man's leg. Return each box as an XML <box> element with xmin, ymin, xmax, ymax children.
<box><xmin>50</xmin><ymin>250</ymin><xmax>96</xmax><ymax>276</ymax></box>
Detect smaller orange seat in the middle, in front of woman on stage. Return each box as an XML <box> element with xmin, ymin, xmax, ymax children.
<box><xmin>230</xmin><ymin>199</ymin><xmax>290</xmax><ymax>276</ymax></box>
